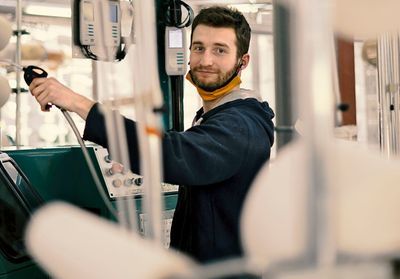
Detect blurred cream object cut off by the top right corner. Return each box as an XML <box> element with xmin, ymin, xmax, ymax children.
<box><xmin>333</xmin><ymin>0</ymin><xmax>400</xmax><ymax>39</ymax></box>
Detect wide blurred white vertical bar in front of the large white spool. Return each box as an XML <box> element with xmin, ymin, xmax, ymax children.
<box><xmin>292</xmin><ymin>0</ymin><xmax>337</xmax><ymax>270</ymax></box>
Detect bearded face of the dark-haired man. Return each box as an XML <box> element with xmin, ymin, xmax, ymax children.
<box><xmin>190</xmin><ymin>24</ymin><xmax>238</xmax><ymax>91</ymax></box>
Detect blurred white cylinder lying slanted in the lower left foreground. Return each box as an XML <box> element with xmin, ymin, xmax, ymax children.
<box><xmin>25</xmin><ymin>202</ymin><xmax>192</xmax><ymax>279</ymax></box>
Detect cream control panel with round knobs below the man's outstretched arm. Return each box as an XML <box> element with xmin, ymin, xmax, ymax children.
<box><xmin>94</xmin><ymin>147</ymin><xmax>178</xmax><ymax>198</ymax></box>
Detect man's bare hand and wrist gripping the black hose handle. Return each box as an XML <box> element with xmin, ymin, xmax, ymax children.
<box><xmin>29</xmin><ymin>78</ymin><xmax>95</xmax><ymax>120</ymax></box>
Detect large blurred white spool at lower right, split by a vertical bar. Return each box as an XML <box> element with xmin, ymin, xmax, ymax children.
<box><xmin>241</xmin><ymin>141</ymin><xmax>400</xmax><ymax>266</ymax></box>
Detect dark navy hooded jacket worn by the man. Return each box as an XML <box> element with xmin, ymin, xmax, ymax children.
<box><xmin>84</xmin><ymin>98</ymin><xmax>274</xmax><ymax>262</ymax></box>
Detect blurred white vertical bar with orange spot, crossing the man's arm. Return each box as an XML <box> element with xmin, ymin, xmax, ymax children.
<box><xmin>135</xmin><ymin>0</ymin><xmax>163</xmax><ymax>244</ymax></box>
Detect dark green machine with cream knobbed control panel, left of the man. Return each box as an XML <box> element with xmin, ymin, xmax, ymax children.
<box><xmin>0</xmin><ymin>146</ymin><xmax>177</xmax><ymax>278</ymax></box>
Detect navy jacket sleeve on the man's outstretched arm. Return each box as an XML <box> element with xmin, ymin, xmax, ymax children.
<box><xmin>83</xmin><ymin>105</ymin><xmax>249</xmax><ymax>185</ymax></box>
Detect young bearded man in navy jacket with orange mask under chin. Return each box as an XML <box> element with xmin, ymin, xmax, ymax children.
<box><xmin>30</xmin><ymin>7</ymin><xmax>274</xmax><ymax>263</ymax></box>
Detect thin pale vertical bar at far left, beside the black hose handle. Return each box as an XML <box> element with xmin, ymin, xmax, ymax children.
<box><xmin>15</xmin><ymin>0</ymin><xmax>22</xmax><ymax>148</ymax></box>
